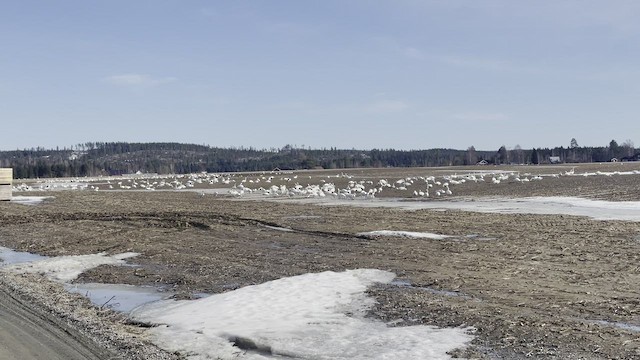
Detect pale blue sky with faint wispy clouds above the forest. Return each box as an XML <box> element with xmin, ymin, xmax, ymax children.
<box><xmin>0</xmin><ymin>0</ymin><xmax>640</xmax><ymax>150</ymax></box>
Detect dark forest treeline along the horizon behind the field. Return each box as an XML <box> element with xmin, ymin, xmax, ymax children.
<box><xmin>0</xmin><ymin>139</ymin><xmax>639</xmax><ymax>178</ymax></box>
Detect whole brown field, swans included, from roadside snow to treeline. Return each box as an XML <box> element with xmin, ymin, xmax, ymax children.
<box><xmin>0</xmin><ymin>163</ymin><xmax>640</xmax><ymax>359</ymax></box>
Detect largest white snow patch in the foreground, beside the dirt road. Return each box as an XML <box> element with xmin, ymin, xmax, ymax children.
<box><xmin>131</xmin><ymin>269</ymin><xmax>472</xmax><ymax>359</ymax></box>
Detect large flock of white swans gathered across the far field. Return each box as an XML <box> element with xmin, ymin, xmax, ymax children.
<box><xmin>8</xmin><ymin>168</ymin><xmax>640</xmax><ymax>199</ymax></box>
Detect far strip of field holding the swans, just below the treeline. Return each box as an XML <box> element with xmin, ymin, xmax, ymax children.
<box><xmin>14</xmin><ymin>162</ymin><xmax>640</xmax><ymax>200</ymax></box>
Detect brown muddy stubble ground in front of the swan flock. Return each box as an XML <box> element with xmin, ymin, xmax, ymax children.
<box><xmin>0</xmin><ymin>167</ymin><xmax>640</xmax><ymax>359</ymax></box>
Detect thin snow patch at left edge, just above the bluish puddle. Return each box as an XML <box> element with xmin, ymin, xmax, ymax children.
<box><xmin>4</xmin><ymin>252</ymin><xmax>139</xmax><ymax>282</ymax></box>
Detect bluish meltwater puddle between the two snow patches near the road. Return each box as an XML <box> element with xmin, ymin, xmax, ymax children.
<box><xmin>64</xmin><ymin>283</ymin><xmax>172</xmax><ymax>313</ymax></box>
